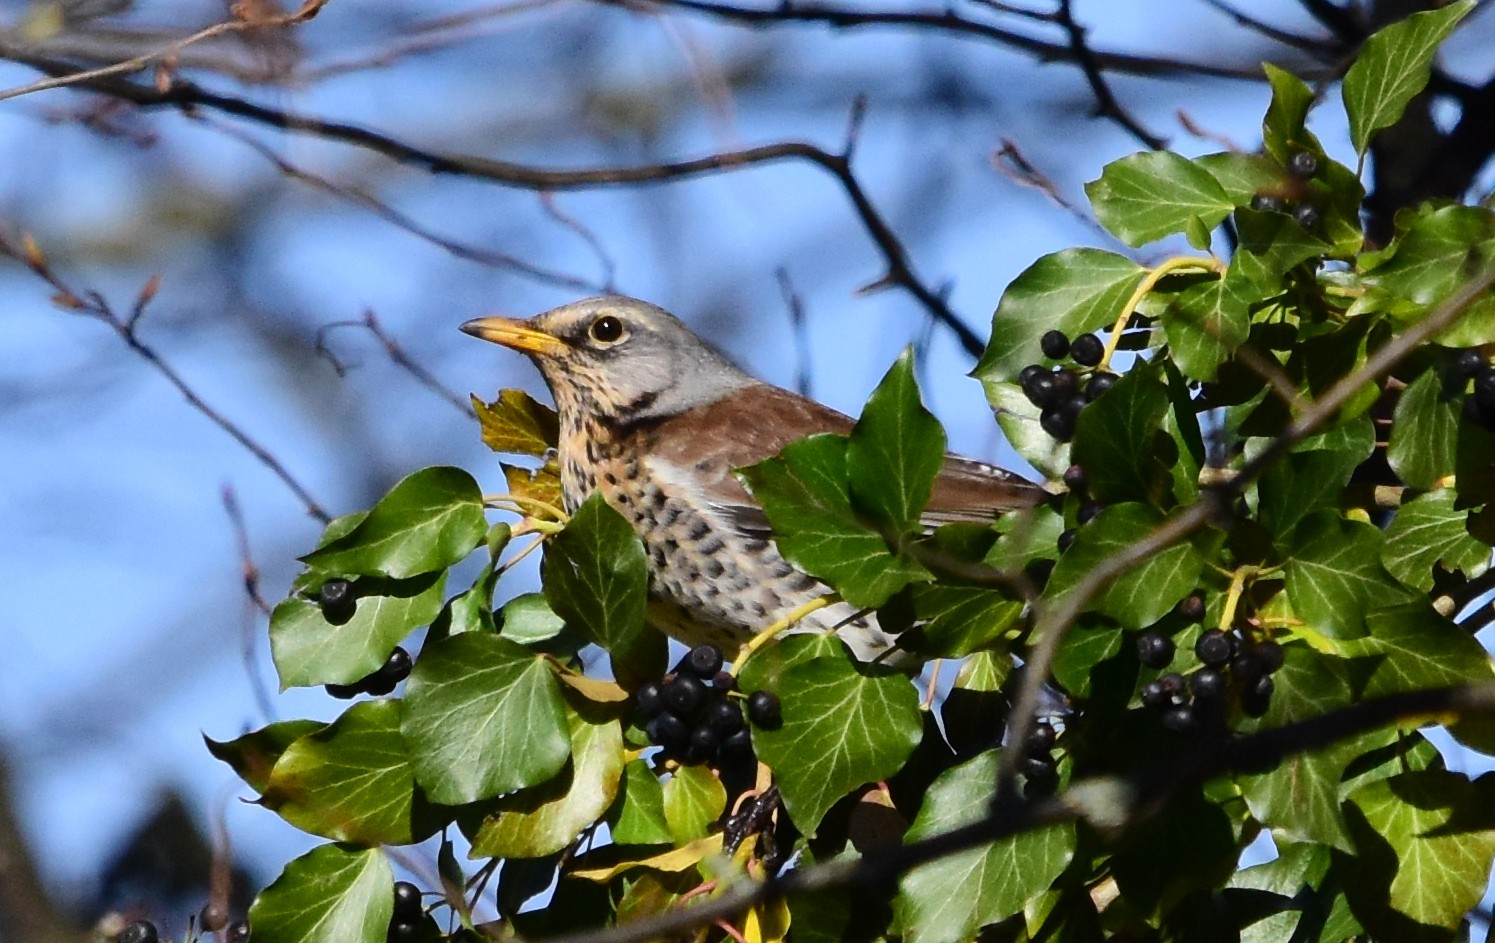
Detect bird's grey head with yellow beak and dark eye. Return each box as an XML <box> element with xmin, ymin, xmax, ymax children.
<box><xmin>462</xmin><ymin>296</ymin><xmax>755</xmax><ymax>423</ymax></box>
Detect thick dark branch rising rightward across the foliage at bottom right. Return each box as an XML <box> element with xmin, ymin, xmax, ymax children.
<box><xmin>538</xmin><ymin>681</ymin><xmax>1495</xmax><ymax>943</ymax></box>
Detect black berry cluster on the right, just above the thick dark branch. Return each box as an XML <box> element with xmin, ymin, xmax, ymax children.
<box><xmin>1136</xmin><ymin>630</ymin><xmax>1283</xmax><ymax>732</ymax></box>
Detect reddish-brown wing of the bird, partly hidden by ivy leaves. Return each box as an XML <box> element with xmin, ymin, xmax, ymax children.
<box><xmin>653</xmin><ymin>384</ymin><xmax>1048</xmax><ymax>537</ymax></box>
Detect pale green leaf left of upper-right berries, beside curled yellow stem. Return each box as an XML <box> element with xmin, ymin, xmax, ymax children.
<box><xmin>970</xmin><ymin>248</ymin><xmax>1145</xmax><ymax>381</ymax></box>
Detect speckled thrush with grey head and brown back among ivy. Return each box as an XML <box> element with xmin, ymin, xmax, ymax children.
<box><xmin>460</xmin><ymin>296</ymin><xmax>1048</xmax><ymax>661</ymax></box>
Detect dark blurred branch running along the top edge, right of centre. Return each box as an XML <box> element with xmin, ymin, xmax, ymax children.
<box><xmin>597</xmin><ymin>0</ymin><xmax>1285</xmax><ymax>82</ymax></box>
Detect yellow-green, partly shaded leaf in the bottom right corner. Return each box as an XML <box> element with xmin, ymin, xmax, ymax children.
<box><xmin>1346</xmin><ymin>770</ymin><xmax>1495</xmax><ymax>939</ymax></box>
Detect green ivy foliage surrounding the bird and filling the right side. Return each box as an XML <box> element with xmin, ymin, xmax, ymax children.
<box><xmin>208</xmin><ymin>0</ymin><xmax>1495</xmax><ymax>943</ymax></box>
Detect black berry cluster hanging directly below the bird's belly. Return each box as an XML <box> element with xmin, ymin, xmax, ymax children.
<box><xmin>634</xmin><ymin>646</ymin><xmax>783</xmax><ymax>767</ymax></box>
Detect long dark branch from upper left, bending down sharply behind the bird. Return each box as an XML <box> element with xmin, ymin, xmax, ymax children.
<box><xmin>0</xmin><ymin>57</ymin><xmax>985</xmax><ymax>357</ymax></box>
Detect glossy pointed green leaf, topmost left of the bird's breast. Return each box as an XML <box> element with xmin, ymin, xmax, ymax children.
<box><xmin>302</xmin><ymin>466</ymin><xmax>487</xmax><ymax>580</ymax></box>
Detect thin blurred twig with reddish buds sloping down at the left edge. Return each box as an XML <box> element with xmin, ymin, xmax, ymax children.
<box><xmin>0</xmin><ymin>228</ymin><xmax>332</xmax><ymax>523</ymax></box>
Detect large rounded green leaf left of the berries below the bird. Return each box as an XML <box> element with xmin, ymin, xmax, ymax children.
<box><xmin>401</xmin><ymin>632</ymin><xmax>571</xmax><ymax>806</ymax></box>
